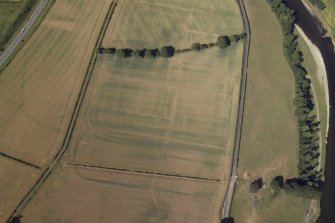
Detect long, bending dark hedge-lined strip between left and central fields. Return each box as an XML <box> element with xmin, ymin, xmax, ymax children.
<box><xmin>7</xmin><ymin>0</ymin><xmax>117</xmax><ymax>222</ymax></box>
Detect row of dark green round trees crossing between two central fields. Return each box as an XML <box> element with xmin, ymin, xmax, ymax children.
<box><xmin>98</xmin><ymin>33</ymin><xmax>246</xmax><ymax>58</ymax></box>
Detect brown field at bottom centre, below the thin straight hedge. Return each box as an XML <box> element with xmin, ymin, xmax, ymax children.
<box><xmin>22</xmin><ymin>166</ymin><xmax>226</xmax><ymax>223</ymax></box>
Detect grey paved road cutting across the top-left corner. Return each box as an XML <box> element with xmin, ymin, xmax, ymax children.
<box><xmin>0</xmin><ymin>0</ymin><xmax>49</xmax><ymax>66</ymax></box>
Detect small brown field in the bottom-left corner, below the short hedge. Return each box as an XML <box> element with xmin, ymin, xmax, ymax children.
<box><xmin>0</xmin><ymin>156</ymin><xmax>40</xmax><ymax>222</ymax></box>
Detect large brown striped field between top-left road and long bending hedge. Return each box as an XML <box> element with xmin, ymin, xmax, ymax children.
<box><xmin>0</xmin><ymin>0</ymin><xmax>111</xmax><ymax>166</ymax></box>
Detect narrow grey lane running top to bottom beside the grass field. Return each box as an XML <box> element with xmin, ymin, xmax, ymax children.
<box><xmin>222</xmin><ymin>0</ymin><xmax>250</xmax><ymax>218</ymax></box>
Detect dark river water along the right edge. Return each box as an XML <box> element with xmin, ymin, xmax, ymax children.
<box><xmin>286</xmin><ymin>0</ymin><xmax>335</xmax><ymax>223</ymax></box>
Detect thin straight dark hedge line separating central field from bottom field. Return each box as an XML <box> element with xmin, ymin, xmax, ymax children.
<box><xmin>64</xmin><ymin>163</ymin><xmax>224</xmax><ymax>182</ymax></box>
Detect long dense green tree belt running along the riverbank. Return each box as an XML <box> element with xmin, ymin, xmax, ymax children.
<box><xmin>262</xmin><ymin>0</ymin><xmax>322</xmax><ymax>199</ymax></box>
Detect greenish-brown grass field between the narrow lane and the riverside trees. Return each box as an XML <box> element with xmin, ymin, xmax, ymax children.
<box><xmin>232</xmin><ymin>0</ymin><xmax>309</xmax><ymax>222</ymax></box>
